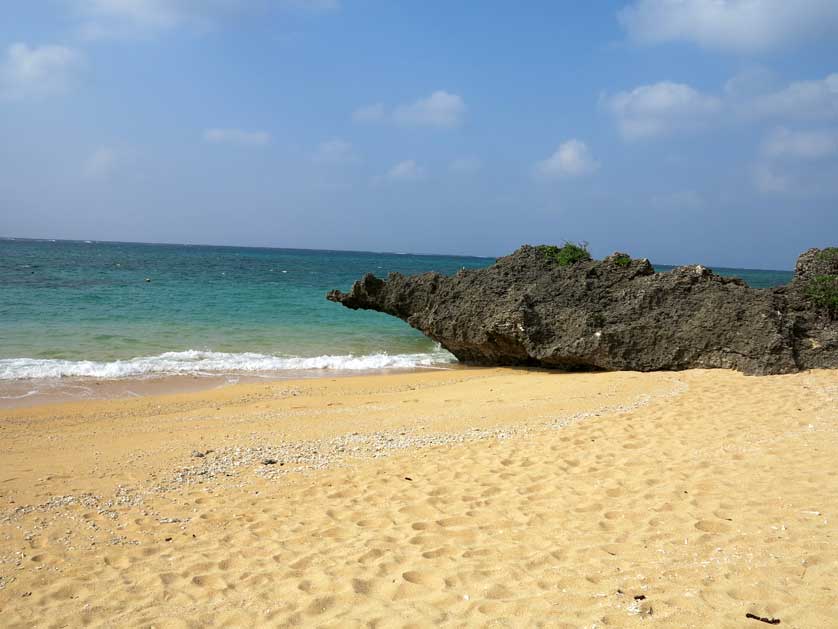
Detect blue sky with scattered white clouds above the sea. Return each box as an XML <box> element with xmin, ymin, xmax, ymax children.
<box><xmin>0</xmin><ymin>0</ymin><xmax>838</xmax><ymax>269</ymax></box>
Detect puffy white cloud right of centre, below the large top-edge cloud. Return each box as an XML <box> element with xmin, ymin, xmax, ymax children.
<box><xmin>601</xmin><ymin>81</ymin><xmax>722</xmax><ymax>140</ymax></box>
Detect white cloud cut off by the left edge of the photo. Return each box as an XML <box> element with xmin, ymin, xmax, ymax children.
<box><xmin>0</xmin><ymin>43</ymin><xmax>84</xmax><ymax>100</ymax></box>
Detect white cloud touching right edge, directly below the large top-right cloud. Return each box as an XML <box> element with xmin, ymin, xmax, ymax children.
<box><xmin>753</xmin><ymin>73</ymin><xmax>838</xmax><ymax>118</ymax></box>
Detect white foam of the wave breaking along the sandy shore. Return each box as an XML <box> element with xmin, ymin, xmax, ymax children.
<box><xmin>0</xmin><ymin>349</ymin><xmax>455</xmax><ymax>380</ymax></box>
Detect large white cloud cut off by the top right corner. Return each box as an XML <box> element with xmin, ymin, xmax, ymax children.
<box><xmin>617</xmin><ymin>0</ymin><xmax>838</xmax><ymax>52</ymax></box>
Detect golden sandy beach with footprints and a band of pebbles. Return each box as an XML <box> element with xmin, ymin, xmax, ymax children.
<box><xmin>0</xmin><ymin>369</ymin><xmax>838</xmax><ymax>629</ymax></box>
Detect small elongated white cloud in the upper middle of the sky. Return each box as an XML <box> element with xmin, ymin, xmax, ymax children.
<box><xmin>352</xmin><ymin>90</ymin><xmax>467</xmax><ymax>127</ymax></box>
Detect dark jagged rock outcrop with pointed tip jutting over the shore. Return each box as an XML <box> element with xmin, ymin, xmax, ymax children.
<box><xmin>327</xmin><ymin>245</ymin><xmax>838</xmax><ymax>374</ymax></box>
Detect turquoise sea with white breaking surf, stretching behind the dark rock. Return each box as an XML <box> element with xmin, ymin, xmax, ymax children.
<box><xmin>0</xmin><ymin>240</ymin><xmax>791</xmax><ymax>380</ymax></box>
